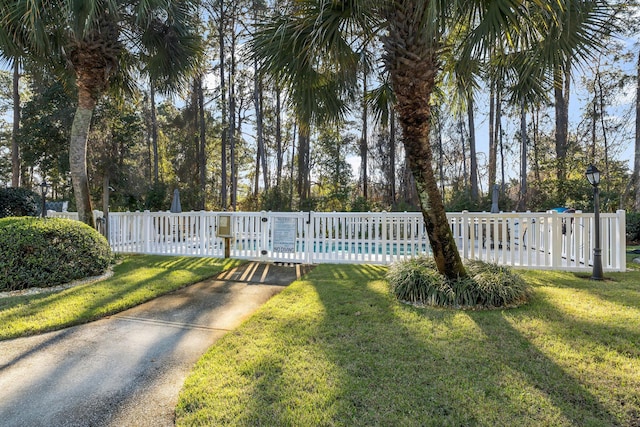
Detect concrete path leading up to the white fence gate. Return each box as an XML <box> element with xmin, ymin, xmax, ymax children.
<box><xmin>0</xmin><ymin>263</ymin><xmax>310</xmax><ymax>427</ymax></box>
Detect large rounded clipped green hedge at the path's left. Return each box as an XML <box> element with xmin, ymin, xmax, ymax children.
<box><xmin>0</xmin><ymin>217</ymin><xmax>113</xmax><ymax>291</ymax></box>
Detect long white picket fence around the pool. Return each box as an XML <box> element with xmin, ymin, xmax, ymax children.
<box><xmin>50</xmin><ymin>210</ymin><xmax>626</xmax><ymax>271</ymax></box>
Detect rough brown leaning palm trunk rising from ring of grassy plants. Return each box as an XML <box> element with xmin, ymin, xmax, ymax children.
<box><xmin>384</xmin><ymin>4</ymin><xmax>467</xmax><ymax>279</ymax></box>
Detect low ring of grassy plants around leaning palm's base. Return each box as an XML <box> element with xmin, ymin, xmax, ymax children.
<box><xmin>387</xmin><ymin>256</ymin><xmax>529</xmax><ymax>308</ymax></box>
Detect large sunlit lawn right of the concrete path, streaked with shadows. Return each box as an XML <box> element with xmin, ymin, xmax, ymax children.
<box><xmin>176</xmin><ymin>265</ymin><xmax>640</xmax><ymax>426</ymax></box>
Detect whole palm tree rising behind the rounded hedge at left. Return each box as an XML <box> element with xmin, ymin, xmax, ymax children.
<box><xmin>0</xmin><ymin>0</ymin><xmax>200</xmax><ymax>225</ymax></box>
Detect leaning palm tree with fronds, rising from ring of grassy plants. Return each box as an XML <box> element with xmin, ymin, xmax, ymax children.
<box><xmin>253</xmin><ymin>0</ymin><xmax>609</xmax><ymax>278</ymax></box>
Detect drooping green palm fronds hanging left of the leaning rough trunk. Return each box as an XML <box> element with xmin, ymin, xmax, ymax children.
<box><xmin>250</xmin><ymin>0</ymin><xmax>379</xmax><ymax>130</ymax></box>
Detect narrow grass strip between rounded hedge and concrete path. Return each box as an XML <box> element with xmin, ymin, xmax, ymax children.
<box><xmin>0</xmin><ymin>255</ymin><xmax>240</xmax><ymax>340</ymax></box>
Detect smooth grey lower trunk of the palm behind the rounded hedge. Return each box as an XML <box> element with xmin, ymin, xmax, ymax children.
<box><xmin>69</xmin><ymin>104</ymin><xmax>95</xmax><ymax>227</ymax></box>
